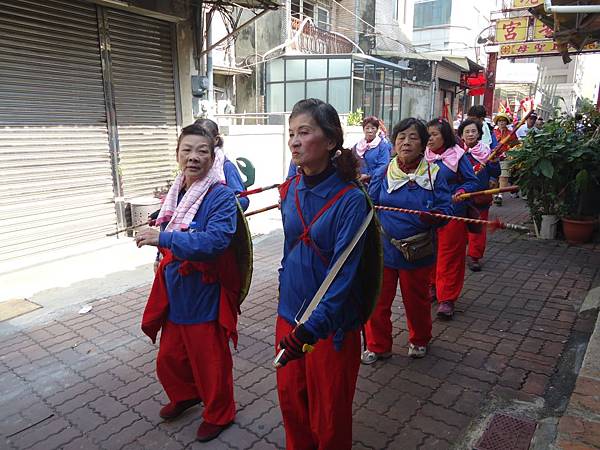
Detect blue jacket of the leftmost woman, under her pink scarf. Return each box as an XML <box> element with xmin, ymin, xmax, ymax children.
<box><xmin>158</xmin><ymin>184</ymin><xmax>237</xmax><ymax>324</ymax></box>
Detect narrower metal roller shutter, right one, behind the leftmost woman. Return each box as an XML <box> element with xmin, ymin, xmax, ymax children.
<box><xmin>107</xmin><ymin>9</ymin><xmax>177</xmax><ymax>200</ymax></box>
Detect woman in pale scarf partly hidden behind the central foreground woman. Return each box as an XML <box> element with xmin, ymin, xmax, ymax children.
<box><xmin>354</xmin><ymin>116</ymin><xmax>392</xmax><ymax>183</ymax></box>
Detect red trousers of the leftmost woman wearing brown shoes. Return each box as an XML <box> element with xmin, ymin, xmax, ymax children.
<box><xmin>156</xmin><ymin>321</ymin><xmax>235</xmax><ymax>425</ymax></box>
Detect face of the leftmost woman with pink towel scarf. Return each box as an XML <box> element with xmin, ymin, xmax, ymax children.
<box><xmin>177</xmin><ymin>134</ymin><xmax>214</xmax><ymax>187</ymax></box>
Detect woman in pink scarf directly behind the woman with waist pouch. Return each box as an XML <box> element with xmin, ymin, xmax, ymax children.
<box><xmin>425</xmin><ymin>119</ymin><xmax>479</xmax><ymax>319</ymax></box>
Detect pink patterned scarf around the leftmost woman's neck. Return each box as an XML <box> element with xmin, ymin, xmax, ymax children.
<box><xmin>156</xmin><ymin>147</ymin><xmax>225</xmax><ymax>231</ymax></box>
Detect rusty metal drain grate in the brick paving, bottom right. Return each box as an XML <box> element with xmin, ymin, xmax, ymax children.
<box><xmin>474</xmin><ymin>414</ymin><xmax>536</xmax><ymax>450</ymax></box>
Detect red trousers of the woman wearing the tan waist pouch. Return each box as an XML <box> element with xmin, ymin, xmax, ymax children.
<box><xmin>365</xmin><ymin>265</ymin><xmax>433</xmax><ymax>353</ymax></box>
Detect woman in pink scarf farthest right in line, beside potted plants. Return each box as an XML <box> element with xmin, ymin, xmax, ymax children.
<box><xmin>458</xmin><ymin>119</ymin><xmax>500</xmax><ymax>272</ymax></box>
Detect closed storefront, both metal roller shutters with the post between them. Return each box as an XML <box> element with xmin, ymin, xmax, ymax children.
<box><xmin>0</xmin><ymin>0</ymin><xmax>179</xmax><ymax>261</ymax></box>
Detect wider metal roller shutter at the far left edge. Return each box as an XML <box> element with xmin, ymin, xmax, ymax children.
<box><xmin>0</xmin><ymin>0</ymin><xmax>116</xmax><ymax>261</ymax></box>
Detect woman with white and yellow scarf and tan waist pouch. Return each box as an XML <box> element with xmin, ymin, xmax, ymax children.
<box><xmin>362</xmin><ymin>117</ymin><xmax>452</xmax><ymax>364</ymax></box>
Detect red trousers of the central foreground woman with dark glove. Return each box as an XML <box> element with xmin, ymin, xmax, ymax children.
<box><xmin>275</xmin><ymin>317</ymin><xmax>360</xmax><ymax>450</ymax></box>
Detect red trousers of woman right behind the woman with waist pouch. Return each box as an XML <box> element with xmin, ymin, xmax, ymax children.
<box><xmin>434</xmin><ymin>220</ymin><xmax>468</xmax><ymax>302</ymax></box>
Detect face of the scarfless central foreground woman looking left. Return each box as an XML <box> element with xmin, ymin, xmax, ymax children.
<box><xmin>288</xmin><ymin>114</ymin><xmax>335</xmax><ymax>175</ymax></box>
